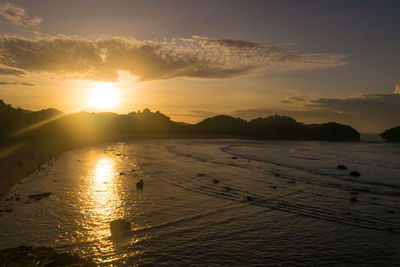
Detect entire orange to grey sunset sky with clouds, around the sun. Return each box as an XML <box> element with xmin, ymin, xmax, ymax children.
<box><xmin>0</xmin><ymin>0</ymin><xmax>400</xmax><ymax>133</ymax></box>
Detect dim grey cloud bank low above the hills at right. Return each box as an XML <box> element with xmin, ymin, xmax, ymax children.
<box><xmin>231</xmin><ymin>94</ymin><xmax>400</xmax><ymax>133</ymax></box>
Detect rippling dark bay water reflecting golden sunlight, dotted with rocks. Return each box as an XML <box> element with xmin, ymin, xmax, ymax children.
<box><xmin>0</xmin><ymin>139</ymin><xmax>400</xmax><ymax>266</ymax></box>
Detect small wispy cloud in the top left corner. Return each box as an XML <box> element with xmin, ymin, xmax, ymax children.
<box><xmin>0</xmin><ymin>2</ymin><xmax>42</xmax><ymax>28</ymax></box>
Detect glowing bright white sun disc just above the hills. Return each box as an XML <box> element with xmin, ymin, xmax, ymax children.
<box><xmin>90</xmin><ymin>82</ymin><xmax>119</xmax><ymax>109</ymax></box>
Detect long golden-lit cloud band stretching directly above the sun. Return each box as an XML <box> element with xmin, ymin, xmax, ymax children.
<box><xmin>0</xmin><ymin>35</ymin><xmax>345</xmax><ymax>81</ymax></box>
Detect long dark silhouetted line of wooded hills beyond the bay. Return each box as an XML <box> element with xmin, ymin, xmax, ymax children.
<box><xmin>0</xmin><ymin>101</ymin><xmax>360</xmax><ymax>144</ymax></box>
